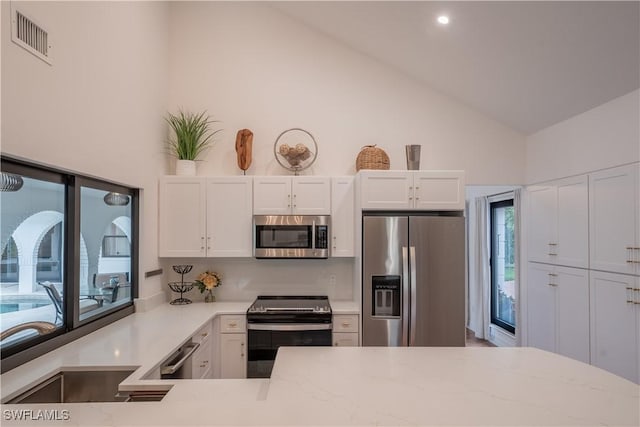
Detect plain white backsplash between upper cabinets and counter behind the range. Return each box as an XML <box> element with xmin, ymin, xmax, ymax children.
<box><xmin>163</xmin><ymin>258</ymin><xmax>355</xmax><ymax>301</ymax></box>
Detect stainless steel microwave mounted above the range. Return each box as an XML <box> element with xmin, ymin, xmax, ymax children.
<box><xmin>253</xmin><ymin>215</ymin><xmax>331</xmax><ymax>258</ymax></box>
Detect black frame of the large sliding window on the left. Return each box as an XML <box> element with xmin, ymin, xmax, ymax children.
<box><xmin>0</xmin><ymin>154</ymin><xmax>140</xmax><ymax>372</ymax></box>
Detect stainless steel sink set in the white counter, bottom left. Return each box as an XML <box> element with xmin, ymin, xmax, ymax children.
<box><xmin>6</xmin><ymin>369</ymin><xmax>134</xmax><ymax>403</ymax></box>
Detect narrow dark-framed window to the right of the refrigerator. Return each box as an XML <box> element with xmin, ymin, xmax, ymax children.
<box><xmin>490</xmin><ymin>199</ymin><xmax>516</xmax><ymax>333</ymax></box>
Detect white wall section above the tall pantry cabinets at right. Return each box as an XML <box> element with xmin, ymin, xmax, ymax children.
<box><xmin>526</xmin><ymin>90</ymin><xmax>640</xmax><ymax>184</ymax></box>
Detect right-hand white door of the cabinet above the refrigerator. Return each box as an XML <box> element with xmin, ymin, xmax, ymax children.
<box><xmin>413</xmin><ymin>171</ymin><xmax>465</xmax><ymax>210</ymax></box>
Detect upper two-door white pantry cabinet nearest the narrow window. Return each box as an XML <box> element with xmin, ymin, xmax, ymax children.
<box><xmin>527</xmin><ymin>175</ymin><xmax>589</xmax><ymax>268</ymax></box>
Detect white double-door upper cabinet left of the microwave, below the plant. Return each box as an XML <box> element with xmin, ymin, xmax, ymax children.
<box><xmin>158</xmin><ymin>176</ymin><xmax>252</xmax><ymax>257</ymax></box>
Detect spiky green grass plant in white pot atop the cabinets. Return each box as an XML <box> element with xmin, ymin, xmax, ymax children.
<box><xmin>165</xmin><ymin>110</ymin><xmax>221</xmax><ymax>175</ymax></box>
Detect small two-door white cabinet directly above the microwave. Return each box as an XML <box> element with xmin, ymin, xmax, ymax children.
<box><xmin>253</xmin><ymin>176</ymin><xmax>331</xmax><ymax>215</ymax></box>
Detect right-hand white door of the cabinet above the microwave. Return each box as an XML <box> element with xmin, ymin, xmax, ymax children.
<box><xmin>291</xmin><ymin>176</ymin><xmax>331</xmax><ymax>215</ymax></box>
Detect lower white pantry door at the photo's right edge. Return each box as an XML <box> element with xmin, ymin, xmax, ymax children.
<box><xmin>591</xmin><ymin>271</ymin><xmax>640</xmax><ymax>383</ymax></box>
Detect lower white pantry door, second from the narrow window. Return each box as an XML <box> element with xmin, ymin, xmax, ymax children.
<box><xmin>552</xmin><ymin>267</ymin><xmax>590</xmax><ymax>363</ymax></box>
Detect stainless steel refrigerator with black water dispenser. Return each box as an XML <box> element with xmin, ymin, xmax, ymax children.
<box><xmin>362</xmin><ymin>212</ymin><xmax>465</xmax><ymax>346</ymax></box>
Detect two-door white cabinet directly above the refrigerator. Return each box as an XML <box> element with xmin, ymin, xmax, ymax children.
<box><xmin>359</xmin><ymin>170</ymin><xmax>465</xmax><ymax>210</ymax></box>
